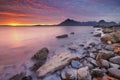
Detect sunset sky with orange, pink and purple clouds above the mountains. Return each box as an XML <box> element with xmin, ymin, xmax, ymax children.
<box><xmin>0</xmin><ymin>0</ymin><xmax>120</xmax><ymax>25</ymax></box>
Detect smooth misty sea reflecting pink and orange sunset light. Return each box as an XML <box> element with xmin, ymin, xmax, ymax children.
<box><xmin>0</xmin><ymin>26</ymin><xmax>93</xmax><ymax>80</ymax></box>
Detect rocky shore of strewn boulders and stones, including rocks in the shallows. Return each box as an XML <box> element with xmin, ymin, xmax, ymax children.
<box><xmin>8</xmin><ymin>25</ymin><xmax>120</xmax><ymax>80</ymax></box>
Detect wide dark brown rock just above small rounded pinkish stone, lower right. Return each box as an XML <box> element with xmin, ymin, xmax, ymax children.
<box><xmin>96</xmin><ymin>50</ymin><xmax>114</xmax><ymax>60</ymax></box>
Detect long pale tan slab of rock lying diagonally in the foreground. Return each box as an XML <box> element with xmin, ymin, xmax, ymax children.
<box><xmin>36</xmin><ymin>52</ymin><xmax>78</xmax><ymax>77</ymax></box>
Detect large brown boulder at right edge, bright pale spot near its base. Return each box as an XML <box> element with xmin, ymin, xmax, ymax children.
<box><xmin>101</xmin><ymin>32</ymin><xmax>120</xmax><ymax>44</ymax></box>
